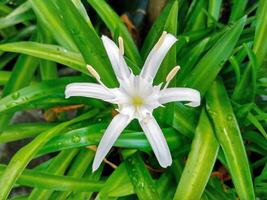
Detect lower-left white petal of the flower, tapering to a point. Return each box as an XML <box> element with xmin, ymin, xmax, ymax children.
<box><xmin>93</xmin><ymin>114</ymin><xmax>131</xmax><ymax>171</ymax></box>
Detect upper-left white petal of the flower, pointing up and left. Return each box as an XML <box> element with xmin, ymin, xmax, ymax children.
<box><xmin>101</xmin><ymin>35</ymin><xmax>130</xmax><ymax>79</ymax></box>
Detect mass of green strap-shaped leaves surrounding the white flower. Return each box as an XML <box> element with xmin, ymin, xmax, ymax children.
<box><xmin>0</xmin><ymin>0</ymin><xmax>267</xmax><ymax>200</ymax></box>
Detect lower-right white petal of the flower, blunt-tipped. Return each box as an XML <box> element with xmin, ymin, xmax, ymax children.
<box><xmin>139</xmin><ymin>116</ymin><xmax>172</xmax><ymax>167</ymax></box>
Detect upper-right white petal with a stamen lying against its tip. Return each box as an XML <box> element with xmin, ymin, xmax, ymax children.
<box><xmin>141</xmin><ymin>33</ymin><xmax>177</xmax><ymax>81</ymax></box>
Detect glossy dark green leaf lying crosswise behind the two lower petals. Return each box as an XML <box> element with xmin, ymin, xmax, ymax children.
<box><xmin>38</xmin><ymin>123</ymin><xmax>181</xmax><ymax>155</ymax></box>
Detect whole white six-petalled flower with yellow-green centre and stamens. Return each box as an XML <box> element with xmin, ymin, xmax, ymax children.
<box><xmin>65</xmin><ymin>32</ymin><xmax>200</xmax><ymax>171</ymax></box>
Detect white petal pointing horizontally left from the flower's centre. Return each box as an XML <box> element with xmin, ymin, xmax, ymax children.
<box><xmin>65</xmin><ymin>83</ymin><xmax>115</xmax><ymax>102</ymax></box>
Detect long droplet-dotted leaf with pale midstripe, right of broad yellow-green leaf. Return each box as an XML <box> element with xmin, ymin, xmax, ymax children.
<box><xmin>206</xmin><ymin>80</ymin><xmax>255</xmax><ymax>200</ymax></box>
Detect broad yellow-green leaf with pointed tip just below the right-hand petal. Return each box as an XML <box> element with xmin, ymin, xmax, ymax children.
<box><xmin>174</xmin><ymin>109</ymin><xmax>219</xmax><ymax>200</ymax></box>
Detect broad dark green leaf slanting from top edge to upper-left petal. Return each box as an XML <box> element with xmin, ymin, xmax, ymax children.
<box><xmin>55</xmin><ymin>0</ymin><xmax>117</xmax><ymax>87</ymax></box>
